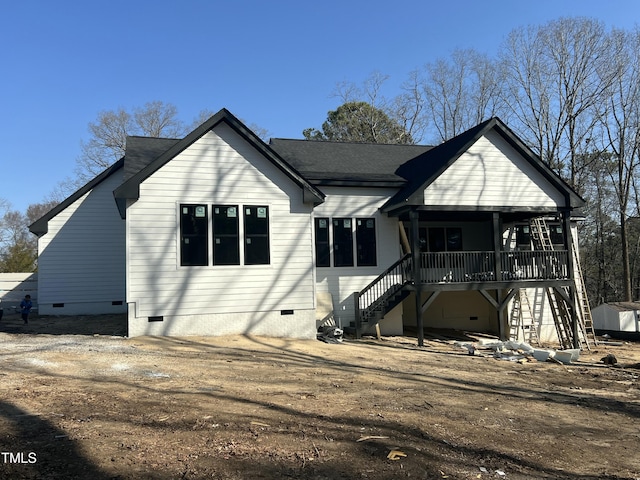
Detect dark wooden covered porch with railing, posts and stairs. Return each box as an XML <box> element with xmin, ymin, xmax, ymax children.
<box><xmin>355</xmin><ymin>206</ymin><xmax>578</xmax><ymax>345</ymax></box>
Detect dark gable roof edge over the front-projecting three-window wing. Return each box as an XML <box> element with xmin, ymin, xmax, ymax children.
<box><xmin>113</xmin><ymin>108</ymin><xmax>324</xmax><ymax>218</ymax></box>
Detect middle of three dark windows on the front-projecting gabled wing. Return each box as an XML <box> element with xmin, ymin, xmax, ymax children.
<box><xmin>213</xmin><ymin>205</ymin><xmax>240</xmax><ymax>265</ymax></box>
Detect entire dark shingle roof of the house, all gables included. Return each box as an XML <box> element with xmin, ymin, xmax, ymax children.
<box><xmin>30</xmin><ymin>109</ymin><xmax>584</xmax><ymax>235</ymax></box>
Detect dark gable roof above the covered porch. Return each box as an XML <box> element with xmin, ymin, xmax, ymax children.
<box><xmin>381</xmin><ymin>117</ymin><xmax>584</xmax><ymax>212</ymax></box>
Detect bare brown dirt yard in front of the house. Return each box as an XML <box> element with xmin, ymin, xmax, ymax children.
<box><xmin>0</xmin><ymin>315</ymin><xmax>640</xmax><ymax>480</ymax></box>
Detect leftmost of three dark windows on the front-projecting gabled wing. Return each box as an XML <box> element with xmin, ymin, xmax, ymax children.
<box><xmin>180</xmin><ymin>205</ymin><xmax>209</xmax><ymax>266</ymax></box>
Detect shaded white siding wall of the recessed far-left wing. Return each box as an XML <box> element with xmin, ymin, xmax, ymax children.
<box><xmin>38</xmin><ymin>172</ymin><xmax>125</xmax><ymax>314</ymax></box>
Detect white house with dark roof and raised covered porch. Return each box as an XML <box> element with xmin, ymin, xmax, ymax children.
<box><xmin>30</xmin><ymin>110</ymin><xmax>583</xmax><ymax>344</ymax></box>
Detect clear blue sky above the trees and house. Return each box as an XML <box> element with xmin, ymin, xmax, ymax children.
<box><xmin>0</xmin><ymin>0</ymin><xmax>640</xmax><ymax>211</ymax></box>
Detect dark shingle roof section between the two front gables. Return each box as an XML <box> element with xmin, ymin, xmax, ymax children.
<box><xmin>270</xmin><ymin>138</ymin><xmax>432</xmax><ymax>187</ymax></box>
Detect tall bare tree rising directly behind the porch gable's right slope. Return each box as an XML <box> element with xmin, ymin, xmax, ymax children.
<box><xmin>500</xmin><ymin>18</ymin><xmax>615</xmax><ymax>186</ymax></box>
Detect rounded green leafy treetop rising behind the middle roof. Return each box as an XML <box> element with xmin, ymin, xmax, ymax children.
<box><xmin>302</xmin><ymin>102</ymin><xmax>413</xmax><ymax>143</ymax></box>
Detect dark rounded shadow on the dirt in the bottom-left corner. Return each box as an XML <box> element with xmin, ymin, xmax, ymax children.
<box><xmin>0</xmin><ymin>400</ymin><xmax>109</xmax><ymax>480</ymax></box>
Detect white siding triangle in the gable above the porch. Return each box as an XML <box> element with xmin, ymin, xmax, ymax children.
<box><xmin>424</xmin><ymin>131</ymin><xmax>565</xmax><ymax>208</ymax></box>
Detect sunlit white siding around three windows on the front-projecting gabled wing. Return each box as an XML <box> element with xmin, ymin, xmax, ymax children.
<box><xmin>127</xmin><ymin>124</ymin><xmax>314</xmax><ymax>326</ymax></box>
